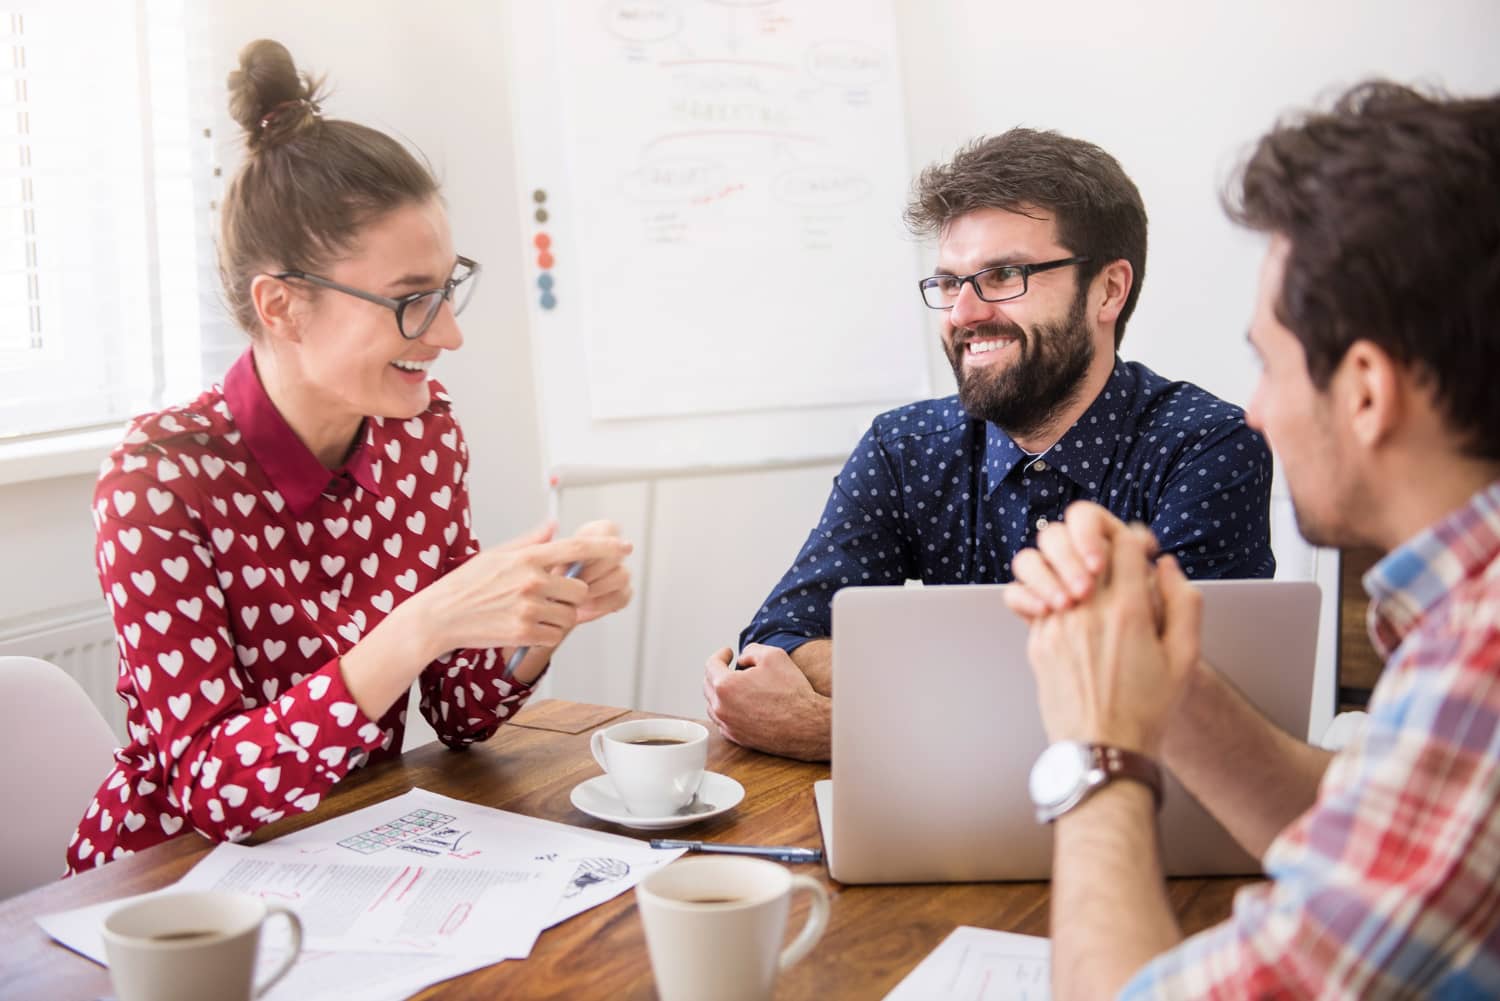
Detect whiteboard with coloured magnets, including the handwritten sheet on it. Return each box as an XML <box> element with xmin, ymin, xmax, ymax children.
<box><xmin>510</xmin><ymin>0</ymin><xmax>930</xmax><ymax>470</ymax></box>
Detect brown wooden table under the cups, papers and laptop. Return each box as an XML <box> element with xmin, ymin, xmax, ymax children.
<box><xmin>0</xmin><ymin>701</ymin><xmax>1250</xmax><ymax>1001</ymax></box>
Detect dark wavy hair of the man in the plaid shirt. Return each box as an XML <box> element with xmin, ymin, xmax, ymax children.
<box><xmin>1224</xmin><ymin>81</ymin><xmax>1500</xmax><ymax>459</ymax></box>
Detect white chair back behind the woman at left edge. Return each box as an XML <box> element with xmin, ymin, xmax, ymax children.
<box><xmin>0</xmin><ymin>657</ymin><xmax>116</xmax><ymax>899</ymax></box>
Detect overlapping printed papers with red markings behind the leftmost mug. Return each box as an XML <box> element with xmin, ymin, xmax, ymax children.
<box><xmin>38</xmin><ymin>789</ymin><xmax>683</xmax><ymax>1001</ymax></box>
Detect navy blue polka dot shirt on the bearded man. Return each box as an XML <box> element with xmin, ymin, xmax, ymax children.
<box><xmin>740</xmin><ymin>360</ymin><xmax>1277</xmax><ymax>651</ymax></box>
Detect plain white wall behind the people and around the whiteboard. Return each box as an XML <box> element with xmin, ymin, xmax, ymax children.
<box><xmin>0</xmin><ymin>0</ymin><xmax>1500</xmax><ymax>732</ymax></box>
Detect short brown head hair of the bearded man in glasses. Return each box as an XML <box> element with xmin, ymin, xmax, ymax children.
<box><xmin>906</xmin><ymin>129</ymin><xmax>1146</xmax><ymax>347</ymax></box>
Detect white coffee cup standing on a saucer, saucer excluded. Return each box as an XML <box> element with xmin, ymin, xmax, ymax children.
<box><xmin>590</xmin><ymin>719</ymin><xmax>708</xmax><ymax>816</ymax></box>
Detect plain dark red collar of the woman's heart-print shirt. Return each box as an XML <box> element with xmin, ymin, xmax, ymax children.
<box><xmin>224</xmin><ymin>350</ymin><xmax>381</xmax><ymax>515</ymax></box>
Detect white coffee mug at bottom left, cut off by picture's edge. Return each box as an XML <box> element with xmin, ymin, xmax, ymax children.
<box><xmin>104</xmin><ymin>890</ymin><xmax>302</xmax><ymax>1001</ymax></box>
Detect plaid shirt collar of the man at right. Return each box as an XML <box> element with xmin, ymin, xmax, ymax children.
<box><xmin>1362</xmin><ymin>480</ymin><xmax>1500</xmax><ymax>657</ymax></box>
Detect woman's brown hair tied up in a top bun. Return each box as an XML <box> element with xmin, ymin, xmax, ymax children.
<box><xmin>219</xmin><ymin>39</ymin><xmax>438</xmax><ymax>335</ymax></box>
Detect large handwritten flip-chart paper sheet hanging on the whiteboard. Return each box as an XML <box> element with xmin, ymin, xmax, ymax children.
<box><xmin>545</xmin><ymin>0</ymin><xmax>926</xmax><ymax>423</ymax></box>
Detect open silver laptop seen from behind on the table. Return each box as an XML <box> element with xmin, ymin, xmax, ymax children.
<box><xmin>815</xmin><ymin>581</ymin><xmax>1320</xmax><ymax>882</ymax></box>
